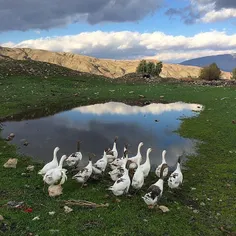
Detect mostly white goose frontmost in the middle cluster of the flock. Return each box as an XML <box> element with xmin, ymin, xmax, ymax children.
<box><xmin>108</xmin><ymin>160</ymin><xmax>131</xmax><ymax>196</ymax></box>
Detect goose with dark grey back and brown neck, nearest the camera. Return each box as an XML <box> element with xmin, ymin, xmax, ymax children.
<box><xmin>142</xmin><ymin>164</ymin><xmax>167</xmax><ymax>208</ymax></box>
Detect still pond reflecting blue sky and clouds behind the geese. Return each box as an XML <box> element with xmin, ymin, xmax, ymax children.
<box><xmin>1</xmin><ymin>102</ymin><xmax>203</xmax><ymax>168</ymax></box>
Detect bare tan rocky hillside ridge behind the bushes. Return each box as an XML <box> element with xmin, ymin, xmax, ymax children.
<box><xmin>0</xmin><ymin>47</ymin><xmax>231</xmax><ymax>79</ymax></box>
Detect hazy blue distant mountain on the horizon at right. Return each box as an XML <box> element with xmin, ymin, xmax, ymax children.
<box><xmin>180</xmin><ymin>53</ymin><xmax>236</xmax><ymax>72</ymax></box>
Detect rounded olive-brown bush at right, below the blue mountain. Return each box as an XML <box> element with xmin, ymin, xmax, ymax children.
<box><xmin>199</xmin><ymin>63</ymin><xmax>221</xmax><ymax>80</ymax></box>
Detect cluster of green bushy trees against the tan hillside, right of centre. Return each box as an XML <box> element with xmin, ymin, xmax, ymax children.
<box><xmin>136</xmin><ymin>60</ymin><xmax>162</xmax><ymax>76</ymax></box>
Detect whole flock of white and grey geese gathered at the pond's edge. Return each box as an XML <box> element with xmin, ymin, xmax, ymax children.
<box><xmin>38</xmin><ymin>137</ymin><xmax>183</xmax><ymax>208</ymax></box>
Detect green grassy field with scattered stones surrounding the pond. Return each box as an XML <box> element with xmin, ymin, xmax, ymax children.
<box><xmin>0</xmin><ymin>76</ymin><xmax>236</xmax><ymax>236</ymax></box>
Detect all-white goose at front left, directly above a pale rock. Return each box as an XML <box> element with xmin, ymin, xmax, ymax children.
<box><xmin>43</xmin><ymin>155</ymin><xmax>67</xmax><ymax>185</ymax></box>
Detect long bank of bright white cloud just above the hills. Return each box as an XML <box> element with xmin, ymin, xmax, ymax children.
<box><xmin>2</xmin><ymin>31</ymin><xmax>236</xmax><ymax>62</ymax></box>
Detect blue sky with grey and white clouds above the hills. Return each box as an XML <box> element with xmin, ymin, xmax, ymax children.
<box><xmin>0</xmin><ymin>0</ymin><xmax>236</xmax><ymax>63</ymax></box>
